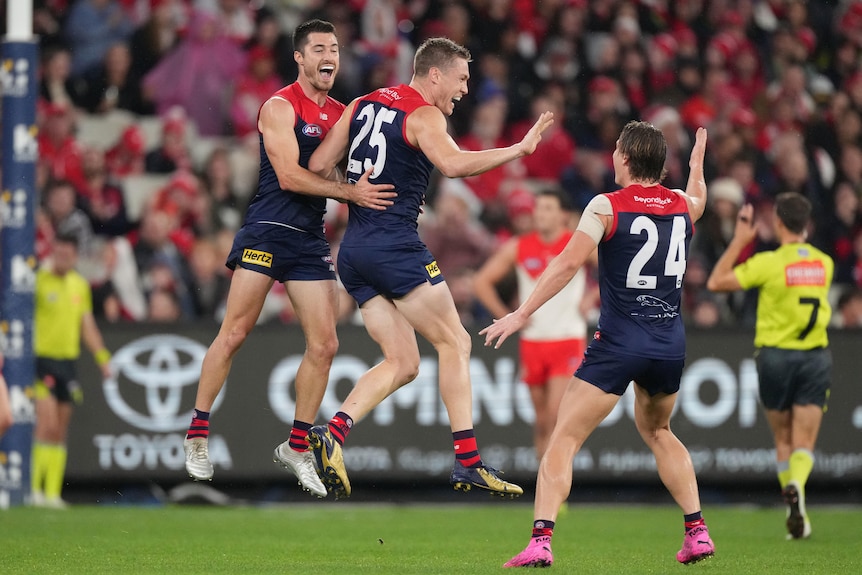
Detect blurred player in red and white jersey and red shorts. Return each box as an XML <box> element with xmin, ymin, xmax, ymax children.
<box><xmin>473</xmin><ymin>189</ymin><xmax>587</xmax><ymax>459</ymax></box>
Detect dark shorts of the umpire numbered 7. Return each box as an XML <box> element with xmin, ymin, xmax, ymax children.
<box><xmin>754</xmin><ymin>347</ymin><xmax>832</xmax><ymax>411</ymax></box>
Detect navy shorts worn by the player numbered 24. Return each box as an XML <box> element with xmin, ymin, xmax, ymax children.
<box><xmin>575</xmin><ymin>340</ymin><xmax>685</xmax><ymax>396</ymax></box>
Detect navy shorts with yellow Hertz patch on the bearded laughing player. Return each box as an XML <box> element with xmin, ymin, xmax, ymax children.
<box><xmin>225</xmin><ymin>224</ymin><xmax>335</xmax><ymax>282</ymax></box>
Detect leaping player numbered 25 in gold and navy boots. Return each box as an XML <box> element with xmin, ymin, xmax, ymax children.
<box><xmin>309</xmin><ymin>38</ymin><xmax>553</xmax><ymax>497</ymax></box>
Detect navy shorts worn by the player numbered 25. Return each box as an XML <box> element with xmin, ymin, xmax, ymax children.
<box><xmin>338</xmin><ymin>243</ymin><xmax>444</xmax><ymax>306</ymax></box>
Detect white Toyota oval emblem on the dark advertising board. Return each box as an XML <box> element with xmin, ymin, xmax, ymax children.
<box><xmin>102</xmin><ymin>334</ymin><xmax>224</xmax><ymax>432</ymax></box>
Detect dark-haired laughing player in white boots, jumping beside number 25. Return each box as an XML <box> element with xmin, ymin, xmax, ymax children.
<box><xmin>184</xmin><ymin>20</ymin><xmax>395</xmax><ymax>497</ymax></box>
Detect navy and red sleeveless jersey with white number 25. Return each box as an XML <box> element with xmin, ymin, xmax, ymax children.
<box><xmin>342</xmin><ymin>84</ymin><xmax>434</xmax><ymax>246</ymax></box>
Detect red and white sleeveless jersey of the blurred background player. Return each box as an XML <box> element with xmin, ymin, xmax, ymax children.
<box><xmin>515</xmin><ymin>232</ymin><xmax>587</xmax><ymax>341</ymax></box>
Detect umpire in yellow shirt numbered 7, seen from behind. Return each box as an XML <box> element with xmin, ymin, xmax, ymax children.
<box><xmin>706</xmin><ymin>192</ymin><xmax>834</xmax><ymax>539</ymax></box>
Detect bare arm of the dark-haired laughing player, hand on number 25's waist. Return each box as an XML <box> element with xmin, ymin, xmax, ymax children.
<box><xmin>258</xmin><ymin>97</ymin><xmax>395</xmax><ymax>210</ymax></box>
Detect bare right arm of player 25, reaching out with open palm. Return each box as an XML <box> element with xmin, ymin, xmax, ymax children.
<box><xmin>407</xmin><ymin>106</ymin><xmax>554</xmax><ymax>178</ymax></box>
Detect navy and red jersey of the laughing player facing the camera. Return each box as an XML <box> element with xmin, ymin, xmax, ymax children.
<box><xmin>245</xmin><ymin>82</ymin><xmax>344</xmax><ymax>238</ymax></box>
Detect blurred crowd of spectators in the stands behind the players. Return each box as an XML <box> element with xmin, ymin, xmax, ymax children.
<box><xmin>5</xmin><ymin>0</ymin><xmax>862</xmax><ymax>329</ymax></box>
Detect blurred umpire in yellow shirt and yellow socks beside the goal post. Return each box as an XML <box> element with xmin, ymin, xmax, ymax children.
<box><xmin>31</xmin><ymin>235</ymin><xmax>111</xmax><ymax>509</ymax></box>
